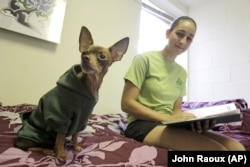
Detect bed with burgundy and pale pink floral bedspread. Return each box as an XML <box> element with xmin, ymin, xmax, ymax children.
<box><xmin>0</xmin><ymin>99</ymin><xmax>250</xmax><ymax>167</ymax></box>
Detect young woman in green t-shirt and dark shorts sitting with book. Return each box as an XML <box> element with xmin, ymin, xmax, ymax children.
<box><xmin>121</xmin><ymin>16</ymin><xmax>245</xmax><ymax>150</ymax></box>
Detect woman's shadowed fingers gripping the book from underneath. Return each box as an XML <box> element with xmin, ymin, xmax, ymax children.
<box><xmin>190</xmin><ymin>120</ymin><xmax>215</xmax><ymax>133</ymax></box>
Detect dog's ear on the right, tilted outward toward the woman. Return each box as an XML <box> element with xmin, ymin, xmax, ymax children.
<box><xmin>109</xmin><ymin>37</ymin><xmax>129</xmax><ymax>62</ymax></box>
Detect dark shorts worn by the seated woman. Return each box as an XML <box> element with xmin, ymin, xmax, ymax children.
<box><xmin>125</xmin><ymin>120</ymin><xmax>162</xmax><ymax>142</ymax></box>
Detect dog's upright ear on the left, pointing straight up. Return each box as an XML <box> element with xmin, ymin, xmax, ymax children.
<box><xmin>79</xmin><ymin>26</ymin><xmax>94</xmax><ymax>53</ymax></box>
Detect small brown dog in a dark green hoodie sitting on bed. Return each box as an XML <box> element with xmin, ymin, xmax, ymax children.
<box><xmin>15</xmin><ymin>26</ymin><xmax>129</xmax><ymax>159</ymax></box>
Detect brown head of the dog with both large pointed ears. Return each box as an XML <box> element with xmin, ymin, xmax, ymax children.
<box><xmin>79</xmin><ymin>26</ymin><xmax>129</xmax><ymax>75</ymax></box>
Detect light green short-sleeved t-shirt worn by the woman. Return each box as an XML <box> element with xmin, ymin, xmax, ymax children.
<box><xmin>124</xmin><ymin>51</ymin><xmax>187</xmax><ymax>123</ymax></box>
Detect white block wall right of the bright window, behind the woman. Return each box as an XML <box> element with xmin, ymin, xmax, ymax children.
<box><xmin>188</xmin><ymin>0</ymin><xmax>250</xmax><ymax>103</ymax></box>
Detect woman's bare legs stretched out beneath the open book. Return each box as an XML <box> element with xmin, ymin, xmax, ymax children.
<box><xmin>143</xmin><ymin>126</ymin><xmax>243</xmax><ymax>150</ymax></box>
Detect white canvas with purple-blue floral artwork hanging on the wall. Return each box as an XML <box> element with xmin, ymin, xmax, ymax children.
<box><xmin>0</xmin><ymin>0</ymin><xmax>66</xmax><ymax>43</ymax></box>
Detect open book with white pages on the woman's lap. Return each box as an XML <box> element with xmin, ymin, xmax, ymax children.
<box><xmin>162</xmin><ymin>103</ymin><xmax>241</xmax><ymax>127</ymax></box>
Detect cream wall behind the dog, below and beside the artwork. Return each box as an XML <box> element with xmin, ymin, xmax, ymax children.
<box><xmin>0</xmin><ymin>0</ymin><xmax>141</xmax><ymax>113</ymax></box>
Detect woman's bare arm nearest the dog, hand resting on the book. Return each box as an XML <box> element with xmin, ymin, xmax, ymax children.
<box><xmin>121</xmin><ymin>81</ymin><xmax>193</xmax><ymax>122</ymax></box>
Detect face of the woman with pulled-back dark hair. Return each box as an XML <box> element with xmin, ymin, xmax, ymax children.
<box><xmin>167</xmin><ymin>20</ymin><xmax>196</xmax><ymax>55</ymax></box>
